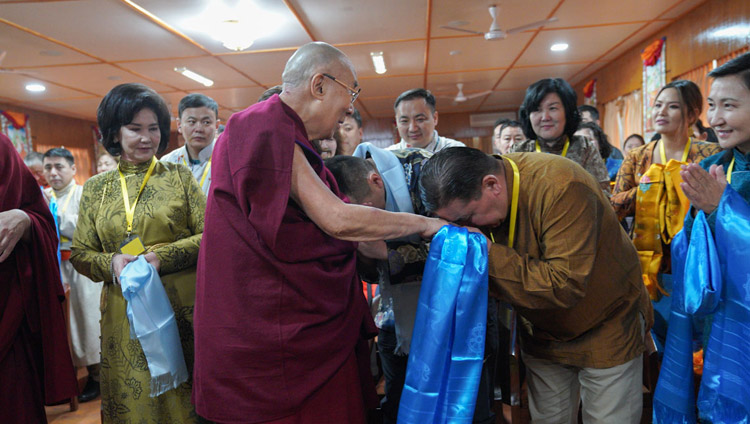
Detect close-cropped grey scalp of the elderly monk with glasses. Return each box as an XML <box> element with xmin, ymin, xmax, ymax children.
<box><xmin>281</xmin><ymin>41</ymin><xmax>354</xmax><ymax>90</ymax></box>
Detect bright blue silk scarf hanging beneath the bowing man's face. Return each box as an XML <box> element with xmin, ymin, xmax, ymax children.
<box><xmin>398</xmin><ymin>225</ymin><xmax>488</xmax><ymax>424</ymax></box>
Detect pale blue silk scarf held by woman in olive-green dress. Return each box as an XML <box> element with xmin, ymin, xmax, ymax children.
<box><xmin>120</xmin><ymin>256</ymin><xmax>188</xmax><ymax>397</ymax></box>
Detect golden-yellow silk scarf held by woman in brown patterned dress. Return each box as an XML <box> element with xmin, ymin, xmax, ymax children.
<box><xmin>633</xmin><ymin>141</ymin><xmax>691</xmax><ymax>300</ymax></box>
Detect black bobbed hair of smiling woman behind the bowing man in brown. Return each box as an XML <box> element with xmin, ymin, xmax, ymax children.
<box><xmin>519</xmin><ymin>78</ymin><xmax>581</xmax><ymax>140</ymax></box>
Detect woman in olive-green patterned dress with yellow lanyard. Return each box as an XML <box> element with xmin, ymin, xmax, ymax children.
<box><xmin>70</xmin><ymin>84</ymin><xmax>206</xmax><ymax>423</ymax></box>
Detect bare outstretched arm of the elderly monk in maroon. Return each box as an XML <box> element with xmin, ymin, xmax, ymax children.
<box><xmin>290</xmin><ymin>146</ymin><xmax>446</xmax><ymax>241</ymax></box>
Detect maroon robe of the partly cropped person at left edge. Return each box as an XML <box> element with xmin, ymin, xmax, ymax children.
<box><xmin>0</xmin><ymin>134</ymin><xmax>78</xmax><ymax>424</ymax></box>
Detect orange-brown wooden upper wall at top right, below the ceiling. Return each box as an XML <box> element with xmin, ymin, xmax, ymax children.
<box><xmin>575</xmin><ymin>0</ymin><xmax>750</xmax><ymax>112</ymax></box>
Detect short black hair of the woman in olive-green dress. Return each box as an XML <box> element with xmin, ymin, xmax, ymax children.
<box><xmin>96</xmin><ymin>83</ymin><xmax>172</xmax><ymax>156</ymax></box>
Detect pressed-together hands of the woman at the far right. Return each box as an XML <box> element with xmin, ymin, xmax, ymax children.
<box><xmin>680</xmin><ymin>163</ymin><xmax>727</xmax><ymax>214</ymax></box>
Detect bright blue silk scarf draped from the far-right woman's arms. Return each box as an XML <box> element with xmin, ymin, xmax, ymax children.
<box><xmin>653</xmin><ymin>186</ymin><xmax>750</xmax><ymax>424</ymax></box>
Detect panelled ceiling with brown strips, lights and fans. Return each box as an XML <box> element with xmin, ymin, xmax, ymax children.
<box><xmin>0</xmin><ymin>0</ymin><xmax>707</xmax><ymax>120</ymax></box>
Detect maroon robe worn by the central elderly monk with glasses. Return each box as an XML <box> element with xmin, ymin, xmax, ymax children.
<box><xmin>193</xmin><ymin>96</ymin><xmax>376</xmax><ymax>423</ymax></box>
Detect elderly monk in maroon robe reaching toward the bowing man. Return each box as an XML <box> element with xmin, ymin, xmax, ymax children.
<box><xmin>193</xmin><ymin>43</ymin><xmax>444</xmax><ymax>424</ymax></box>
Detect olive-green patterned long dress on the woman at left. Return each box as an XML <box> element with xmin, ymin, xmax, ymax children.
<box><xmin>70</xmin><ymin>161</ymin><xmax>206</xmax><ymax>423</ymax></box>
